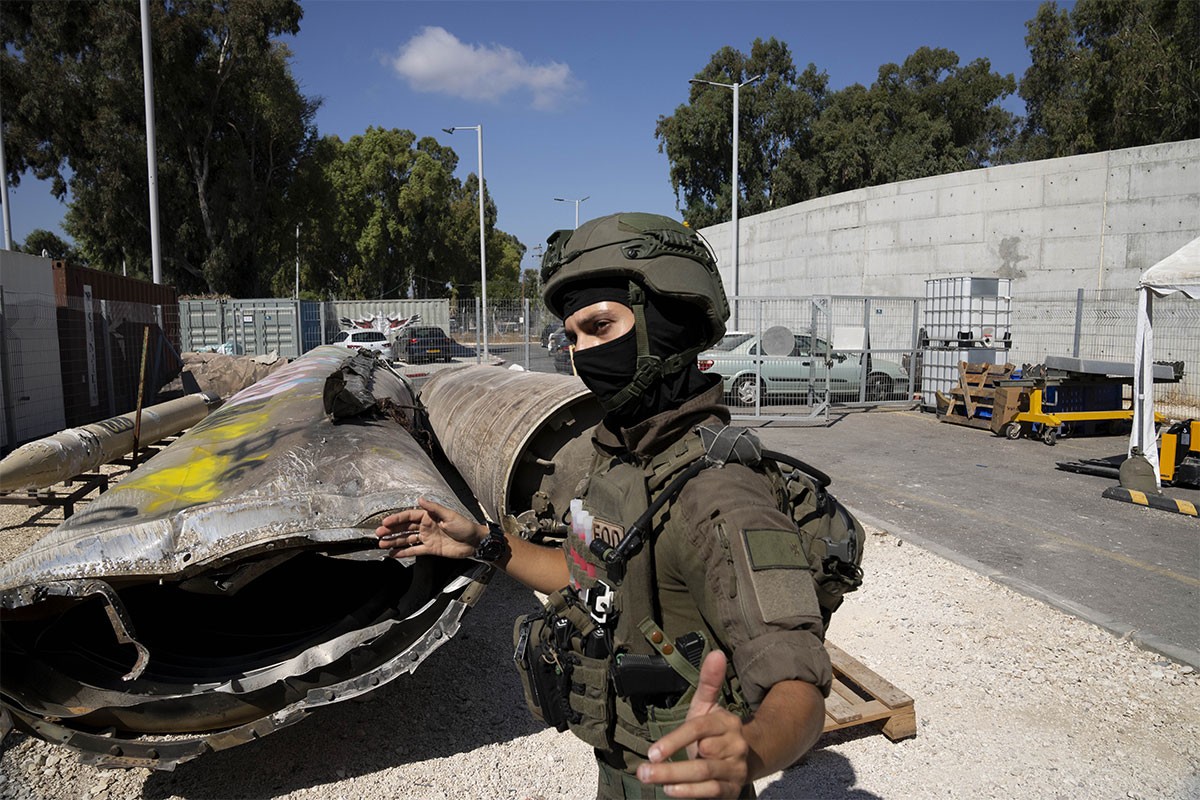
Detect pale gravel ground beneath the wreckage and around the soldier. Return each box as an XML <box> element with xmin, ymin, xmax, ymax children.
<box><xmin>0</xmin><ymin>472</ymin><xmax>1200</xmax><ymax>800</ymax></box>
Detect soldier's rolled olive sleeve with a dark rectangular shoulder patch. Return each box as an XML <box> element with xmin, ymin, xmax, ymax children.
<box><xmin>678</xmin><ymin>464</ymin><xmax>832</xmax><ymax>706</ymax></box>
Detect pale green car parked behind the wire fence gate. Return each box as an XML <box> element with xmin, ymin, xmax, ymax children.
<box><xmin>696</xmin><ymin>331</ymin><xmax>908</xmax><ymax>405</ymax></box>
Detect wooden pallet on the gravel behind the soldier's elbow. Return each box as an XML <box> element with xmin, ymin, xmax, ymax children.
<box><xmin>824</xmin><ymin>642</ymin><xmax>917</xmax><ymax>741</ymax></box>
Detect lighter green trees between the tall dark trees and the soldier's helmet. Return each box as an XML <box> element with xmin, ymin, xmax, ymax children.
<box><xmin>272</xmin><ymin>127</ymin><xmax>524</xmax><ymax>303</ymax></box>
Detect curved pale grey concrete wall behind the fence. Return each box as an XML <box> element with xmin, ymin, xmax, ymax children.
<box><xmin>702</xmin><ymin>139</ymin><xmax>1200</xmax><ymax>296</ymax></box>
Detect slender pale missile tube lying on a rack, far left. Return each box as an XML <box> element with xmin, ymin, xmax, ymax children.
<box><xmin>0</xmin><ymin>393</ymin><xmax>220</xmax><ymax>492</ymax></box>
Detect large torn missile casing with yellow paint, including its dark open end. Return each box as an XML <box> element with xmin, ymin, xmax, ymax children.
<box><xmin>0</xmin><ymin>347</ymin><xmax>490</xmax><ymax>769</ymax></box>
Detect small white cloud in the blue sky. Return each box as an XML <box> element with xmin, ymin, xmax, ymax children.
<box><xmin>391</xmin><ymin>28</ymin><xmax>577</xmax><ymax>110</ymax></box>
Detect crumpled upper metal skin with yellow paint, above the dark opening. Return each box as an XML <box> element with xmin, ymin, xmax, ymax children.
<box><xmin>0</xmin><ymin>345</ymin><xmax>472</xmax><ymax>594</ymax></box>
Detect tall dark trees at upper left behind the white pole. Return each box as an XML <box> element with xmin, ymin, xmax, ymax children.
<box><xmin>0</xmin><ymin>0</ymin><xmax>317</xmax><ymax>295</ymax></box>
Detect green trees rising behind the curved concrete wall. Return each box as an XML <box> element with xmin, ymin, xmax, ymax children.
<box><xmin>655</xmin><ymin>0</ymin><xmax>1200</xmax><ymax>227</ymax></box>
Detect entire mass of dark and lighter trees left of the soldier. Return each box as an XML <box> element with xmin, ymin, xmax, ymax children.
<box><xmin>0</xmin><ymin>0</ymin><xmax>524</xmax><ymax>299</ymax></box>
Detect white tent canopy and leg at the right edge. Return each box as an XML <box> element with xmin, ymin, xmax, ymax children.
<box><xmin>1129</xmin><ymin>237</ymin><xmax>1200</xmax><ymax>486</ymax></box>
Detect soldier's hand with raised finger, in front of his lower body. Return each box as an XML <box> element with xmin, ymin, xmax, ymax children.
<box><xmin>637</xmin><ymin>650</ymin><xmax>750</xmax><ymax>798</ymax></box>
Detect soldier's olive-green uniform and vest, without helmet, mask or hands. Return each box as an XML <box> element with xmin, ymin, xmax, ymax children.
<box><xmin>556</xmin><ymin>386</ymin><xmax>832</xmax><ymax>798</ymax></box>
